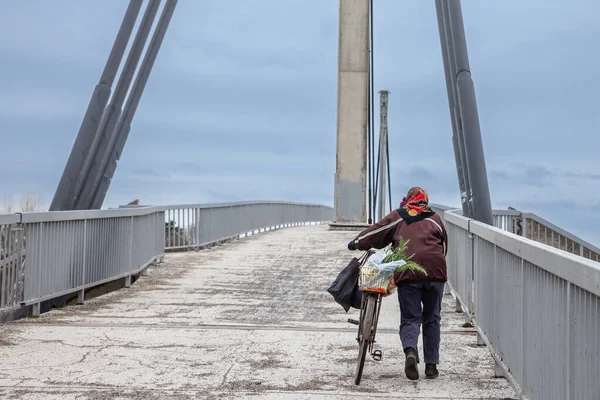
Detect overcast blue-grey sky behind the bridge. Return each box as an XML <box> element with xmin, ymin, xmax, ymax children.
<box><xmin>0</xmin><ymin>0</ymin><xmax>600</xmax><ymax>244</ymax></box>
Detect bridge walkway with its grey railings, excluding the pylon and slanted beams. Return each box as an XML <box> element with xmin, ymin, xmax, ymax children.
<box><xmin>0</xmin><ymin>202</ymin><xmax>600</xmax><ymax>399</ymax></box>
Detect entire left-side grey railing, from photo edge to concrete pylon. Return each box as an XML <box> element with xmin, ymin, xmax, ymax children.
<box><xmin>0</xmin><ymin>202</ymin><xmax>333</xmax><ymax>315</ymax></box>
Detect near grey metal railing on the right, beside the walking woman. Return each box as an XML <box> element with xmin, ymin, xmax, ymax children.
<box><xmin>444</xmin><ymin>211</ymin><xmax>600</xmax><ymax>399</ymax></box>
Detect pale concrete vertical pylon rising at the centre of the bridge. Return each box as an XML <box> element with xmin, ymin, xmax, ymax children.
<box><xmin>335</xmin><ymin>0</ymin><xmax>369</xmax><ymax>223</ymax></box>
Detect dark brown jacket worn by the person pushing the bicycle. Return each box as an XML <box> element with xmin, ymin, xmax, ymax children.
<box><xmin>354</xmin><ymin>210</ymin><xmax>448</xmax><ymax>285</ymax></box>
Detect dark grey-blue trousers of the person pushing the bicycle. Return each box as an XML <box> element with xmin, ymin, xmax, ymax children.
<box><xmin>398</xmin><ymin>282</ymin><xmax>444</xmax><ymax>364</ymax></box>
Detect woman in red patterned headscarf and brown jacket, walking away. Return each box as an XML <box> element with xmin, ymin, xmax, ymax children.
<box><xmin>348</xmin><ymin>187</ymin><xmax>448</xmax><ymax>380</ymax></box>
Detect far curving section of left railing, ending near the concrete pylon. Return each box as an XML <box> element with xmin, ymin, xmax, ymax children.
<box><xmin>161</xmin><ymin>201</ymin><xmax>334</xmax><ymax>250</ymax></box>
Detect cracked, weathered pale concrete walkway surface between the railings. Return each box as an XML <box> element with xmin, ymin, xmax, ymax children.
<box><xmin>0</xmin><ymin>226</ymin><xmax>514</xmax><ymax>399</ymax></box>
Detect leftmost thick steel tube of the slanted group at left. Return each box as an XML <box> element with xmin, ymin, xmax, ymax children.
<box><xmin>50</xmin><ymin>0</ymin><xmax>142</xmax><ymax>211</ymax></box>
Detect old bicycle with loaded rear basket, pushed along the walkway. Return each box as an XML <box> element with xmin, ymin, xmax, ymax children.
<box><xmin>348</xmin><ymin>252</ymin><xmax>391</xmax><ymax>385</ymax></box>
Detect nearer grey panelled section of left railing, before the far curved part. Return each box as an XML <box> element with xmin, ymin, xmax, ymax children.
<box><xmin>20</xmin><ymin>207</ymin><xmax>164</xmax><ymax>314</ymax></box>
